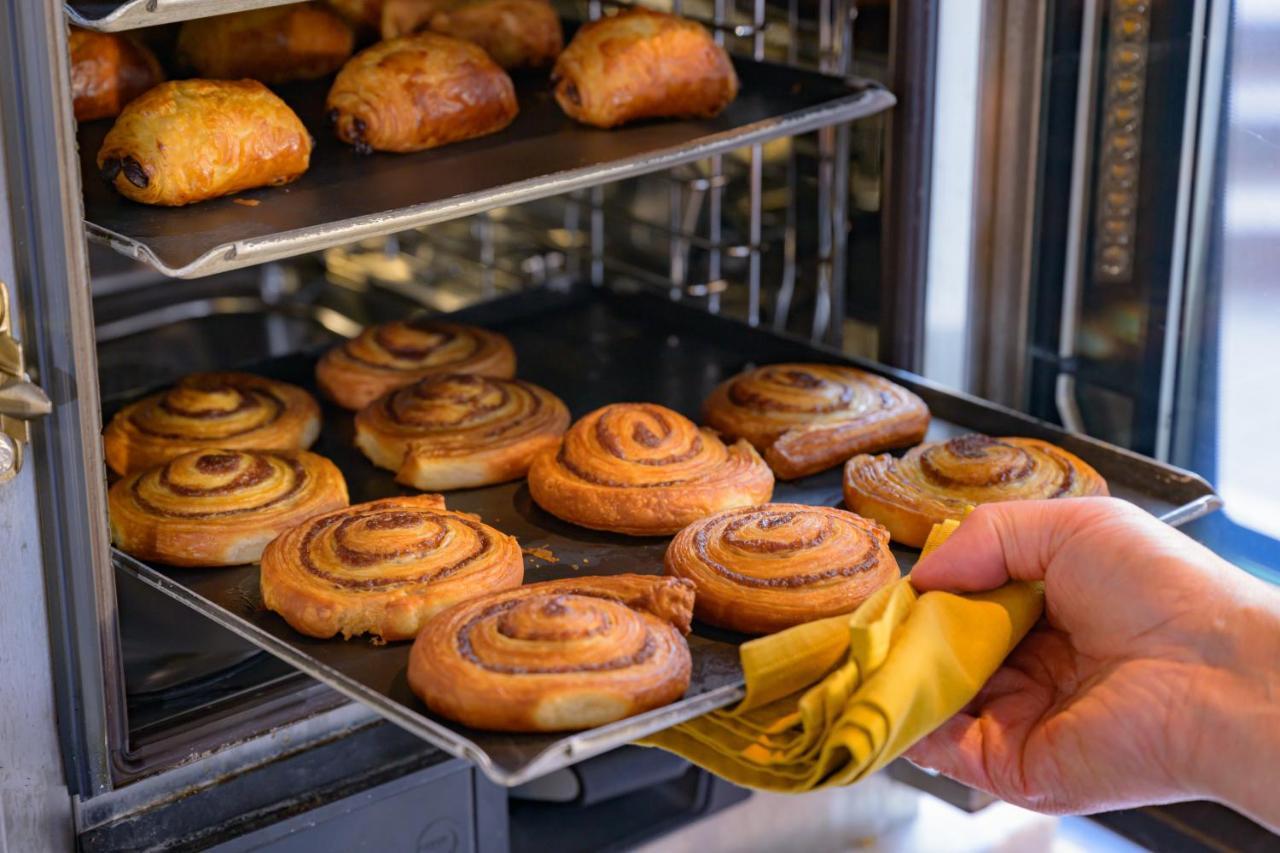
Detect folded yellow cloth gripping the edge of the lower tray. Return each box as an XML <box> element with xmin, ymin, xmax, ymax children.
<box><xmin>640</xmin><ymin>521</ymin><xmax>1043</xmax><ymax>793</ymax></box>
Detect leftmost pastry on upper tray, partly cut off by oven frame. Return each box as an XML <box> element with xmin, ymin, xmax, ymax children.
<box><xmin>67</xmin><ymin>27</ymin><xmax>164</xmax><ymax>122</ymax></box>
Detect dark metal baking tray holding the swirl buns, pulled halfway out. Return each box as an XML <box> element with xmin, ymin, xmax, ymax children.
<box><xmin>116</xmin><ymin>291</ymin><xmax>1217</xmax><ymax>785</ymax></box>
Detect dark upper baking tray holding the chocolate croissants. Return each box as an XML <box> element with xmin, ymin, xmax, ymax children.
<box><xmin>79</xmin><ymin>59</ymin><xmax>893</xmax><ymax>278</ymax></box>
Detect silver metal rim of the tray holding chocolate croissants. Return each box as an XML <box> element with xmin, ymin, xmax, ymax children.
<box><xmin>84</xmin><ymin>77</ymin><xmax>897</xmax><ymax>279</ymax></box>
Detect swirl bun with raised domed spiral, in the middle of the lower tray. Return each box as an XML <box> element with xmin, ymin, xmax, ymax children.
<box><xmin>529</xmin><ymin>403</ymin><xmax>773</xmax><ymax>537</ymax></box>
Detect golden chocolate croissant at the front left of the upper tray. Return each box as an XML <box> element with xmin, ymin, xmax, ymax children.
<box><xmin>97</xmin><ymin>79</ymin><xmax>311</xmax><ymax>206</ymax></box>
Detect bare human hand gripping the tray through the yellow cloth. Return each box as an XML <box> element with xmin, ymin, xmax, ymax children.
<box><xmin>908</xmin><ymin>498</ymin><xmax>1280</xmax><ymax>829</ymax></box>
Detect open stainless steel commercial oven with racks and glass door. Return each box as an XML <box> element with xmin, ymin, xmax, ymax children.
<box><xmin>0</xmin><ymin>0</ymin><xmax>1274</xmax><ymax>850</ymax></box>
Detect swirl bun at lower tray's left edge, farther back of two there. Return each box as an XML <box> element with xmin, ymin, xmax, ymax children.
<box><xmin>102</xmin><ymin>373</ymin><xmax>320</xmax><ymax>474</ymax></box>
